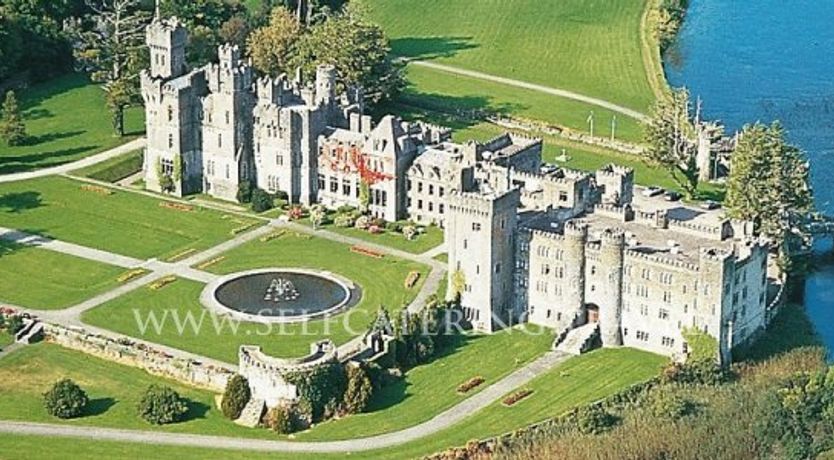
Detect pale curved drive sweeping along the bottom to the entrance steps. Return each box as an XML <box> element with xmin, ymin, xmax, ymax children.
<box><xmin>0</xmin><ymin>351</ymin><xmax>570</xmax><ymax>453</ymax></box>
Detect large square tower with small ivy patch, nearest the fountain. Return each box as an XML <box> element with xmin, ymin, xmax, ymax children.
<box><xmin>446</xmin><ymin>189</ymin><xmax>520</xmax><ymax>332</ymax></box>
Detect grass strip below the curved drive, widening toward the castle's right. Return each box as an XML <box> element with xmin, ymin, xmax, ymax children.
<box><xmin>0</xmin><ymin>349</ymin><xmax>665</xmax><ymax>460</ymax></box>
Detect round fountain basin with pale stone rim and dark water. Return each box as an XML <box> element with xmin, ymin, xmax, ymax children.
<box><xmin>200</xmin><ymin>268</ymin><xmax>361</xmax><ymax>323</ymax></box>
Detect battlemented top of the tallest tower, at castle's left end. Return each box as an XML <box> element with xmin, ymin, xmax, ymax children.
<box><xmin>145</xmin><ymin>17</ymin><xmax>188</xmax><ymax>80</ymax></box>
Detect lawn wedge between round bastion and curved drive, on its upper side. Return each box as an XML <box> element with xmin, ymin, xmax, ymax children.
<box><xmin>296</xmin><ymin>327</ymin><xmax>553</xmax><ymax>441</ymax></box>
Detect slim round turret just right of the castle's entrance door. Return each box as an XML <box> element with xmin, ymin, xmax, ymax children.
<box><xmin>599</xmin><ymin>229</ymin><xmax>625</xmax><ymax>347</ymax></box>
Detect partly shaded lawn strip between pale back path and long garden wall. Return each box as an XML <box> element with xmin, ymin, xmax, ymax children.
<box><xmin>398</xmin><ymin>65</ymin><xmax>645</xmax><ymax>143</ymax></box>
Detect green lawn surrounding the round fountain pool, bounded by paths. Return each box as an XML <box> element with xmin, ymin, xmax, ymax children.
<box><xmin>83</xmin><ymin>234</ymin><xmax>427</xmax><ymax>363</ymax></box>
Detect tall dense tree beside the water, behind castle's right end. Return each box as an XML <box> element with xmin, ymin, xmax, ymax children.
<box><xmin>725</xmin><ymin>122</ymin><xmax>814</xmax><ymax>272</ymax></box>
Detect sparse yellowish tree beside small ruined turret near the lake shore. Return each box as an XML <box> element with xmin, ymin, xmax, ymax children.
<box><xmin>643</xmin><ymin>89</ymin><xmax>698</xmax><ymax>199</ymax></box>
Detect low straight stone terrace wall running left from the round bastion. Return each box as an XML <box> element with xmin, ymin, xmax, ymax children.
<box><xmin>44</xmin><ymin>323</ymin><xmax>234</xmax><ymax>392</ymax></box>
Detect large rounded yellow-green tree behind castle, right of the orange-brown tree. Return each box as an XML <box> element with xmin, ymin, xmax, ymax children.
<box><xmin>291</xmin><ymin>4</ymin><xmax>405</xmax><ymax>103</ymax></box>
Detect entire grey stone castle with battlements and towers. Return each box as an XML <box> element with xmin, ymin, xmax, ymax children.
<box><xmin>141</xmin><ymin>17</ymin><xmax>768</xmax><ymax>360</ymax></box>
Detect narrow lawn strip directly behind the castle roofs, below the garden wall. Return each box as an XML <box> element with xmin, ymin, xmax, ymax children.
<box><xmin>453</xmin><ymin>123</ymin><xmax>724</xmax><ymax>201</ymax></box>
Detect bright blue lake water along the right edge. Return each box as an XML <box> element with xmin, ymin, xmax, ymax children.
<box><xmin>666</xmin><ymin>0</ymin><xmax>834</xmax><ymax>354</ymax></box>
